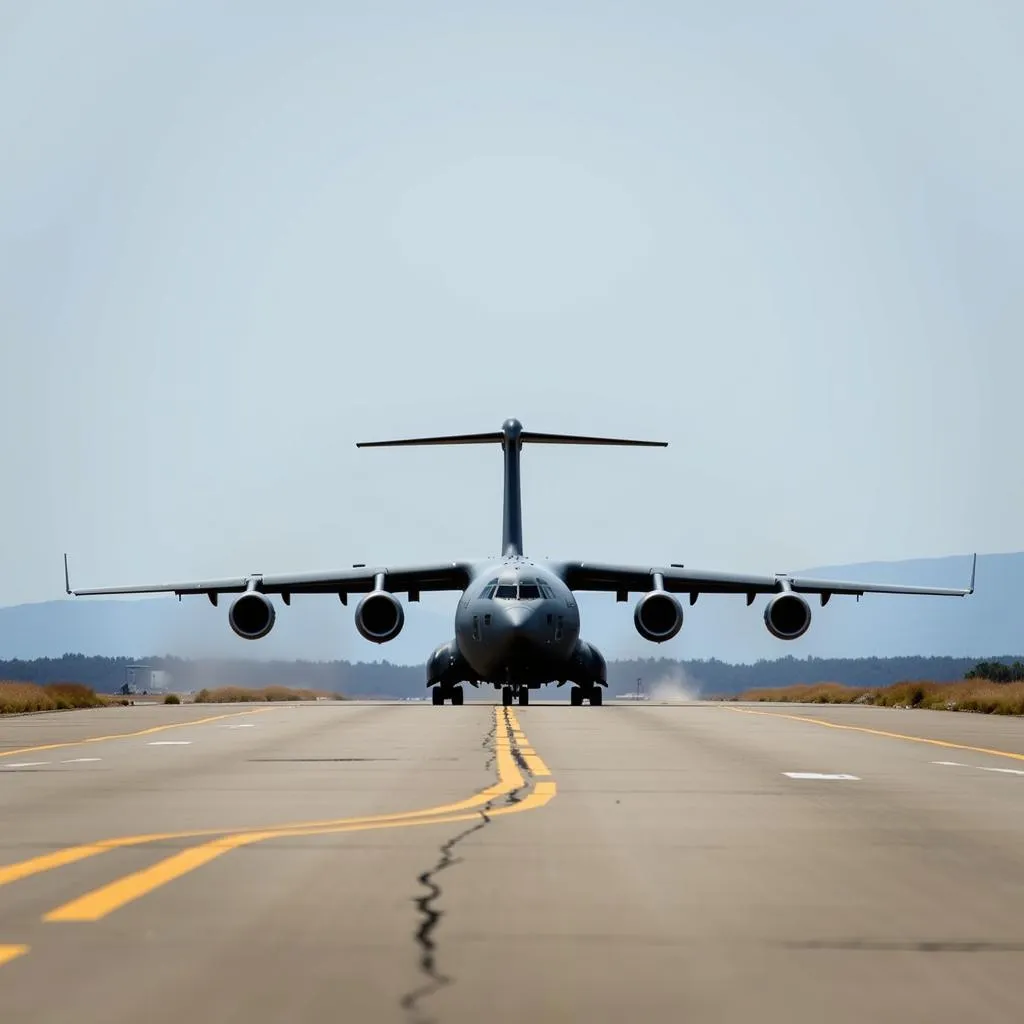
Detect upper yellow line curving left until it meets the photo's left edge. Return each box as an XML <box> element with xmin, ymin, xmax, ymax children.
<box><xmin>0</xmin><ymin>709</ymin><xmax>524</xmax><ymax>886</ymax></box>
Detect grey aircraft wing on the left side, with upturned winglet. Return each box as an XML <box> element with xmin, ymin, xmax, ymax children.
<box><xmin>65</xmin><ymin>555</ymin><xmax>471</xmax><ymax>604</ymax></box>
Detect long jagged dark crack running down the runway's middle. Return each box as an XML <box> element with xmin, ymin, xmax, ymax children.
<box><xmin>400</xmin><ymin>711</ymin><xmax>530</xmax><ymax>1024</ymax></box>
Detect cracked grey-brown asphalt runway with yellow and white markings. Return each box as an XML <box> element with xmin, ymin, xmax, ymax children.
<box><xmin>0</xmin><ymin>702</ymin><xmax>1024</xmax><ymax>1024</ymax></box>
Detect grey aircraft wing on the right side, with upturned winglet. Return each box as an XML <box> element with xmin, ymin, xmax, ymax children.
<box><xmin>558</xmin><ymin>555</ymin><xmax>978</xmax><ymax>604</ymax></box>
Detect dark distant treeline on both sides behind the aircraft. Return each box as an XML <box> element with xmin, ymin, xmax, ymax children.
<box><xmin>0</xmin><ymin>654</ymin><xmax>1024</xmax><ymax>698</ymax></box>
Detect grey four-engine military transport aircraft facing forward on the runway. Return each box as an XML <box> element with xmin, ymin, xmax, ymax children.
<box><xmin>65</xmin><ymin>420</ymin><xmax>977</xmax><ymax>705</ymax></box>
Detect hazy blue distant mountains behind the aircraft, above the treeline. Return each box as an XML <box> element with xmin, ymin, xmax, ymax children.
<box><xmin>0</xmin><ymin>552</ymin><xmax>1003</xmax><ymax>666</ymax></box>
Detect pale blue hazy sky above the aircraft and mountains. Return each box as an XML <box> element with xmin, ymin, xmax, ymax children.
<box><xmin>0</xmin><ymin>0</ymin><xmax>1024</xmax><ymax>606</ymax></box>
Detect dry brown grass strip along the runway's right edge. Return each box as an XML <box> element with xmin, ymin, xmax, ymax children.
<box><xmin>729</xmin><ymin>679</ymin><xmax>1024</xmax><ymax>715</ymax></box>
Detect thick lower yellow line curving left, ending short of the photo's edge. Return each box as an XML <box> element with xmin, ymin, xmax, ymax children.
<box><xmin>43</xmin><ymin>709</ymin><xmax>557</xmax><ymax>923</ymax></box>
